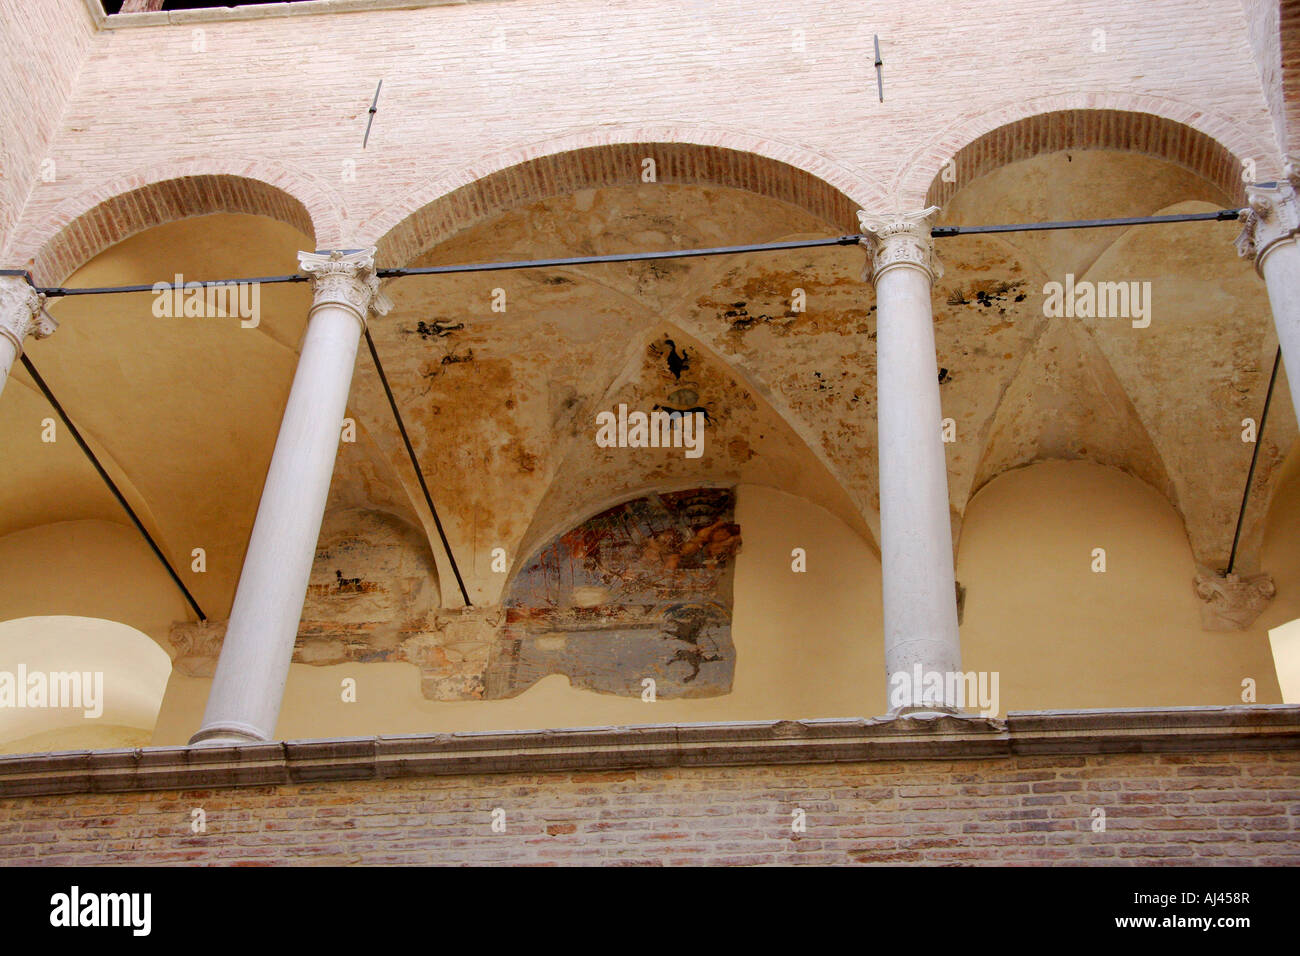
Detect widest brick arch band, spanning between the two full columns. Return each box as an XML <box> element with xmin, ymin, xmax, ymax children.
<box><xmin>371</xmin><ymin>127</ymin><xmax>884</xmax><ymax>267</ymax></box>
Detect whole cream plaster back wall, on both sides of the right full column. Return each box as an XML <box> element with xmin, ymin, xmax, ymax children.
<box><xmin>153</xmin><ymin>462</ymin><xmax>1300</xmax><ymax>745</ymax></box>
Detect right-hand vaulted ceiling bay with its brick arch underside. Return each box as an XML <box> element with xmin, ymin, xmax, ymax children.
<box><xmin>930</xmin><ymin>109</ymin><xmax>1296</xmax><ymax>574</ymax></box>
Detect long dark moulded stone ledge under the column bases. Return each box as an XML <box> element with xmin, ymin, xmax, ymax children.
<box><xmin>0</xmin><ymin>705</ymin><xmax>1300</xmax><ymax>797</ymax></box>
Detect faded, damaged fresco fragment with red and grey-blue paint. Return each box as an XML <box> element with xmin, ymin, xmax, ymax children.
<box><xmin>485</xmin><ymin>488</ymin><xmax>741</xmax><ymax>697</ymax></box>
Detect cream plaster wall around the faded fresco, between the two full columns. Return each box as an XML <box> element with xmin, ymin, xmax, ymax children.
<box><xmin>153</xmin><ymin>485</ymin><xmax>885</xmax><ymax>745</ymax></box>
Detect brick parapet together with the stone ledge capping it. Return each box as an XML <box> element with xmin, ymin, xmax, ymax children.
<box><xmin>0</xmin><ymin>706</ymin><xmax>1300</xmax><ymax>865</ymax></box>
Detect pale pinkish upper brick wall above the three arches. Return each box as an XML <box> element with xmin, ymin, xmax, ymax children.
<box><xmin>0</xmin><ymin>0</ymin><xmax>1279</xmax><ymax>277</ymax></box>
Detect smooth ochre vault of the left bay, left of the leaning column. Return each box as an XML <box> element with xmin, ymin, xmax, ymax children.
<box><xmin>0</xmin><ymin>213</ymin><xmax>311</xmax><ymax>619</ymax></box>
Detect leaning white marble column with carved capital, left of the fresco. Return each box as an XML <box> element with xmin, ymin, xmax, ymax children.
<box><xmin>190</xmin><ymin>248</ymin><xmax>389</xmax><ymax>744</ymax></box>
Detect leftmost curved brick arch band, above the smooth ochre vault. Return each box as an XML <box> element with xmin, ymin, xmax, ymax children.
<box><xmin>16</xmin><ymin>161</ymin><xmax>342</xmax><ymax>285</ymax></box>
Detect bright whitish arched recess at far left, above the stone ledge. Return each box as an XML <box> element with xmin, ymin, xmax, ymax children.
<box><xmin>0</xmin><ymin>615</ymin><xmax>172</xmax><ymax>753</ymax></box>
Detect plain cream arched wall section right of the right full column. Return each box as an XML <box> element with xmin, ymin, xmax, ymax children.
<box><xmin>957</xmin><ymin>460</ymin><xmax>1284</xmax><ymax>711</ymax></box>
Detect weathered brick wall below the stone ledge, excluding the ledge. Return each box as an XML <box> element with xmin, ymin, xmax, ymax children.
<box><xmin>0</xmin><ymin>750</ymin><xmax>1300</xmax><ymax>865</ymax></box>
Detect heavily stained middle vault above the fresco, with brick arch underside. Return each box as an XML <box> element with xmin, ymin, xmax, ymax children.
<box><xmin>355</xmin><ymin>142</ymin><xmax>876</xmax><ymax>605</ymax></box>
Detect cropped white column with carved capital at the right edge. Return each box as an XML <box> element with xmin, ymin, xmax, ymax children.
<box><xmin>1236</xmin><ymin>159</ymin><xmax>1300</xmax><ymax>415</ymax></box>
